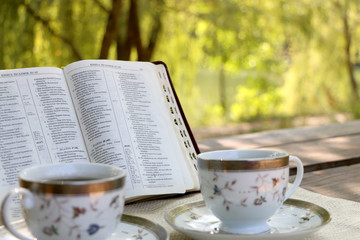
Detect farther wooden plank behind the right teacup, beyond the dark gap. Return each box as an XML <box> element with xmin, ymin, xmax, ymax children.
<box><xmin>199</xmin><ymin>121</ymin><xmax>360</xmax><ymax>171</ymax></box>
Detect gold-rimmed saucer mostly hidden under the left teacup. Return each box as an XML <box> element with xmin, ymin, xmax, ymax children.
<box><xmin>0</xmin><ymin>214</ymin><xmax>169</xmax><ymax>240</ymax></box>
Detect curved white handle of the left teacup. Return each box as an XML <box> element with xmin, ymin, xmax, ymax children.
<box><xmin>1</xmin><ymin>188</ymin><xmax>35</xmax><ymax>240</ymax></box>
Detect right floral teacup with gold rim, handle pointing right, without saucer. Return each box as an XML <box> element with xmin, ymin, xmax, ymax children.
<box><xmin>197</xmin><ymin>149</ymin><xmax>304</xmax><ymax>234</ymax></box>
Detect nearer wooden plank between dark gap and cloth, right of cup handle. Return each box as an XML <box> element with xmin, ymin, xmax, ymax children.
<box><xmin>290</xmin><ymin>164</ymin><xmax>360</xmax><ymax>202</ymax></box>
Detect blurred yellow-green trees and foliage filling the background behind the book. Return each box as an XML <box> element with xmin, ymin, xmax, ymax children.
<box><xmin>0</xmin><ymin>0</ymin><xmax>360</xmax><ymax>127</ymax></box>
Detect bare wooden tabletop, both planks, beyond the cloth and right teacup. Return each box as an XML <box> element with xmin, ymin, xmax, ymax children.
<box><xmin>198</xmin><ymin>120</ymin><xmax>360</xmax><ymax>202</ymax></box>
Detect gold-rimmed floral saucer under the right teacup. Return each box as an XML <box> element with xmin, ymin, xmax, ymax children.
<box><xmin>165</xmin><ymin>199</ymin><xmax>331</xmax><ymax>240</ymax></box>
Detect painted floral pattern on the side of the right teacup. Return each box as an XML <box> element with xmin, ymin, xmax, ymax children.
<box><xmin>201</xmin><ymin>170</ymin><xmax>287</xmax><ymax>211</ymax></box>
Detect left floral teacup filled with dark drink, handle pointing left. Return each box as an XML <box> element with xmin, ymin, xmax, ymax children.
<box><xmin>1</xmin><ymin>163</ymin><xmax>125</xmax><ymax>240</ymax></box>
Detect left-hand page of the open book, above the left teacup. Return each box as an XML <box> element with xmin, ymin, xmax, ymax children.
<box><xmin>0</xmin><ymin>68</ymin><xmax>89</xmax><ymax>220</ymax></box>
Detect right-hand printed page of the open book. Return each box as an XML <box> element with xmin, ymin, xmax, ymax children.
<box><xmin>64</xmin><ymin>60</ymin><xmax>191</xmax><ymax>199</ymax></box>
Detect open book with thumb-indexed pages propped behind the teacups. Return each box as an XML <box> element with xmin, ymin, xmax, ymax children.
<box><xmin>0</xmin><ymin>60</ymin><xmax>199</xmax><ymax>216</ymax></box>
